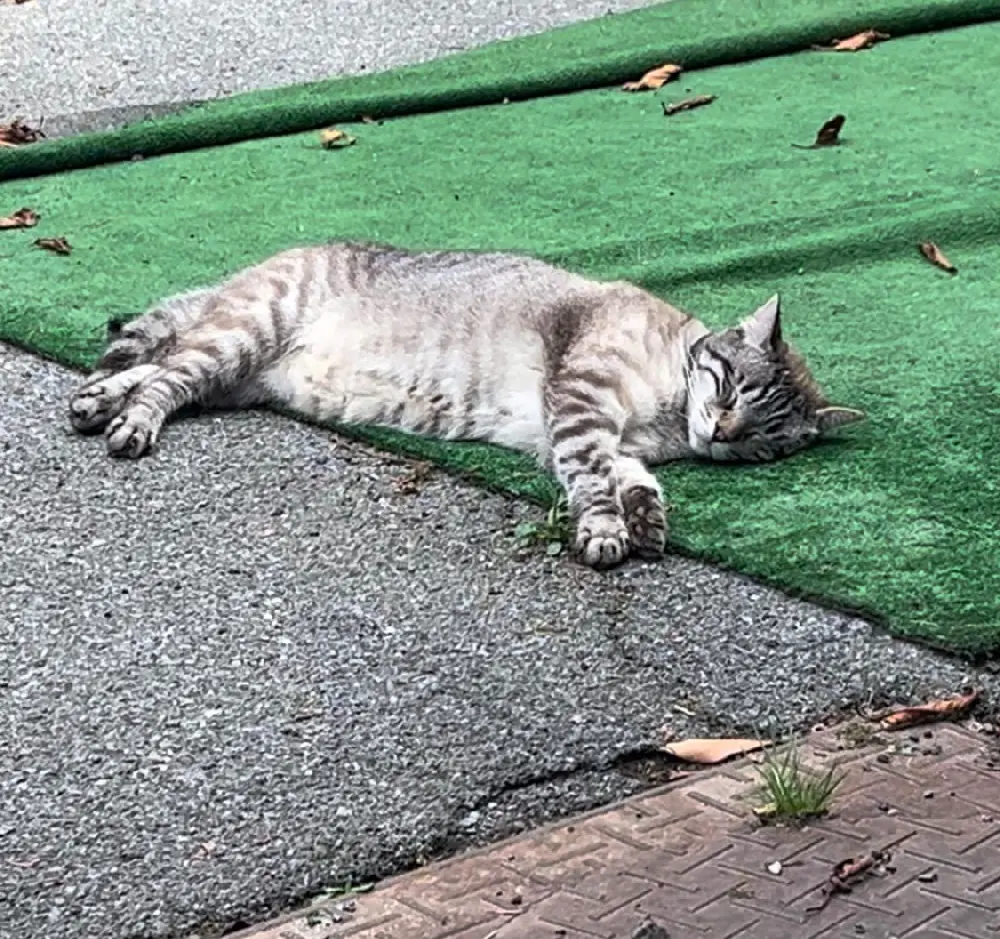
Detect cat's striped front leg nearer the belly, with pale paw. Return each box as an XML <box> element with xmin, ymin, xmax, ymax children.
<box><xmin>546</xmin><ymin>371</ymin><xmax>631</xmax><ymax>568</ymax></box>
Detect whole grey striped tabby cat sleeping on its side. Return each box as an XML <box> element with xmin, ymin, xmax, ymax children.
<box><xmin>70</xmin><ymin>243</ymin><xmax>864</xmax><ymax>568</ymax></box>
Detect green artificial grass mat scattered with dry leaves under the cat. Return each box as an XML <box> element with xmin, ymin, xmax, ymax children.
<box><xmin>0</xmin><ymin>0</ymin><xmax>1000</xmax><ymax>656</ymax></box>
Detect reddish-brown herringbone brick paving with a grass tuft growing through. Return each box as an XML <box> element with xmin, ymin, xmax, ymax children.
<box><xmin>241</xmin><ymin>725</ymin><xmax>1000</xmax><ymax>939</ymax></box>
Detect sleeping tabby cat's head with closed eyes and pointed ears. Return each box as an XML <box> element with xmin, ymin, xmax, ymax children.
<box><xmin>687</xmin><ymin>296</ymin><xmax>865</xmax><ymax>462</ymax></box>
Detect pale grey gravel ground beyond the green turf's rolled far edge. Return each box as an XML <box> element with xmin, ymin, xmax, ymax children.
<box><xmin>0</xmin><ymin>0</ymin><xmax>650</xmax><ymax>121</ymax></box>
